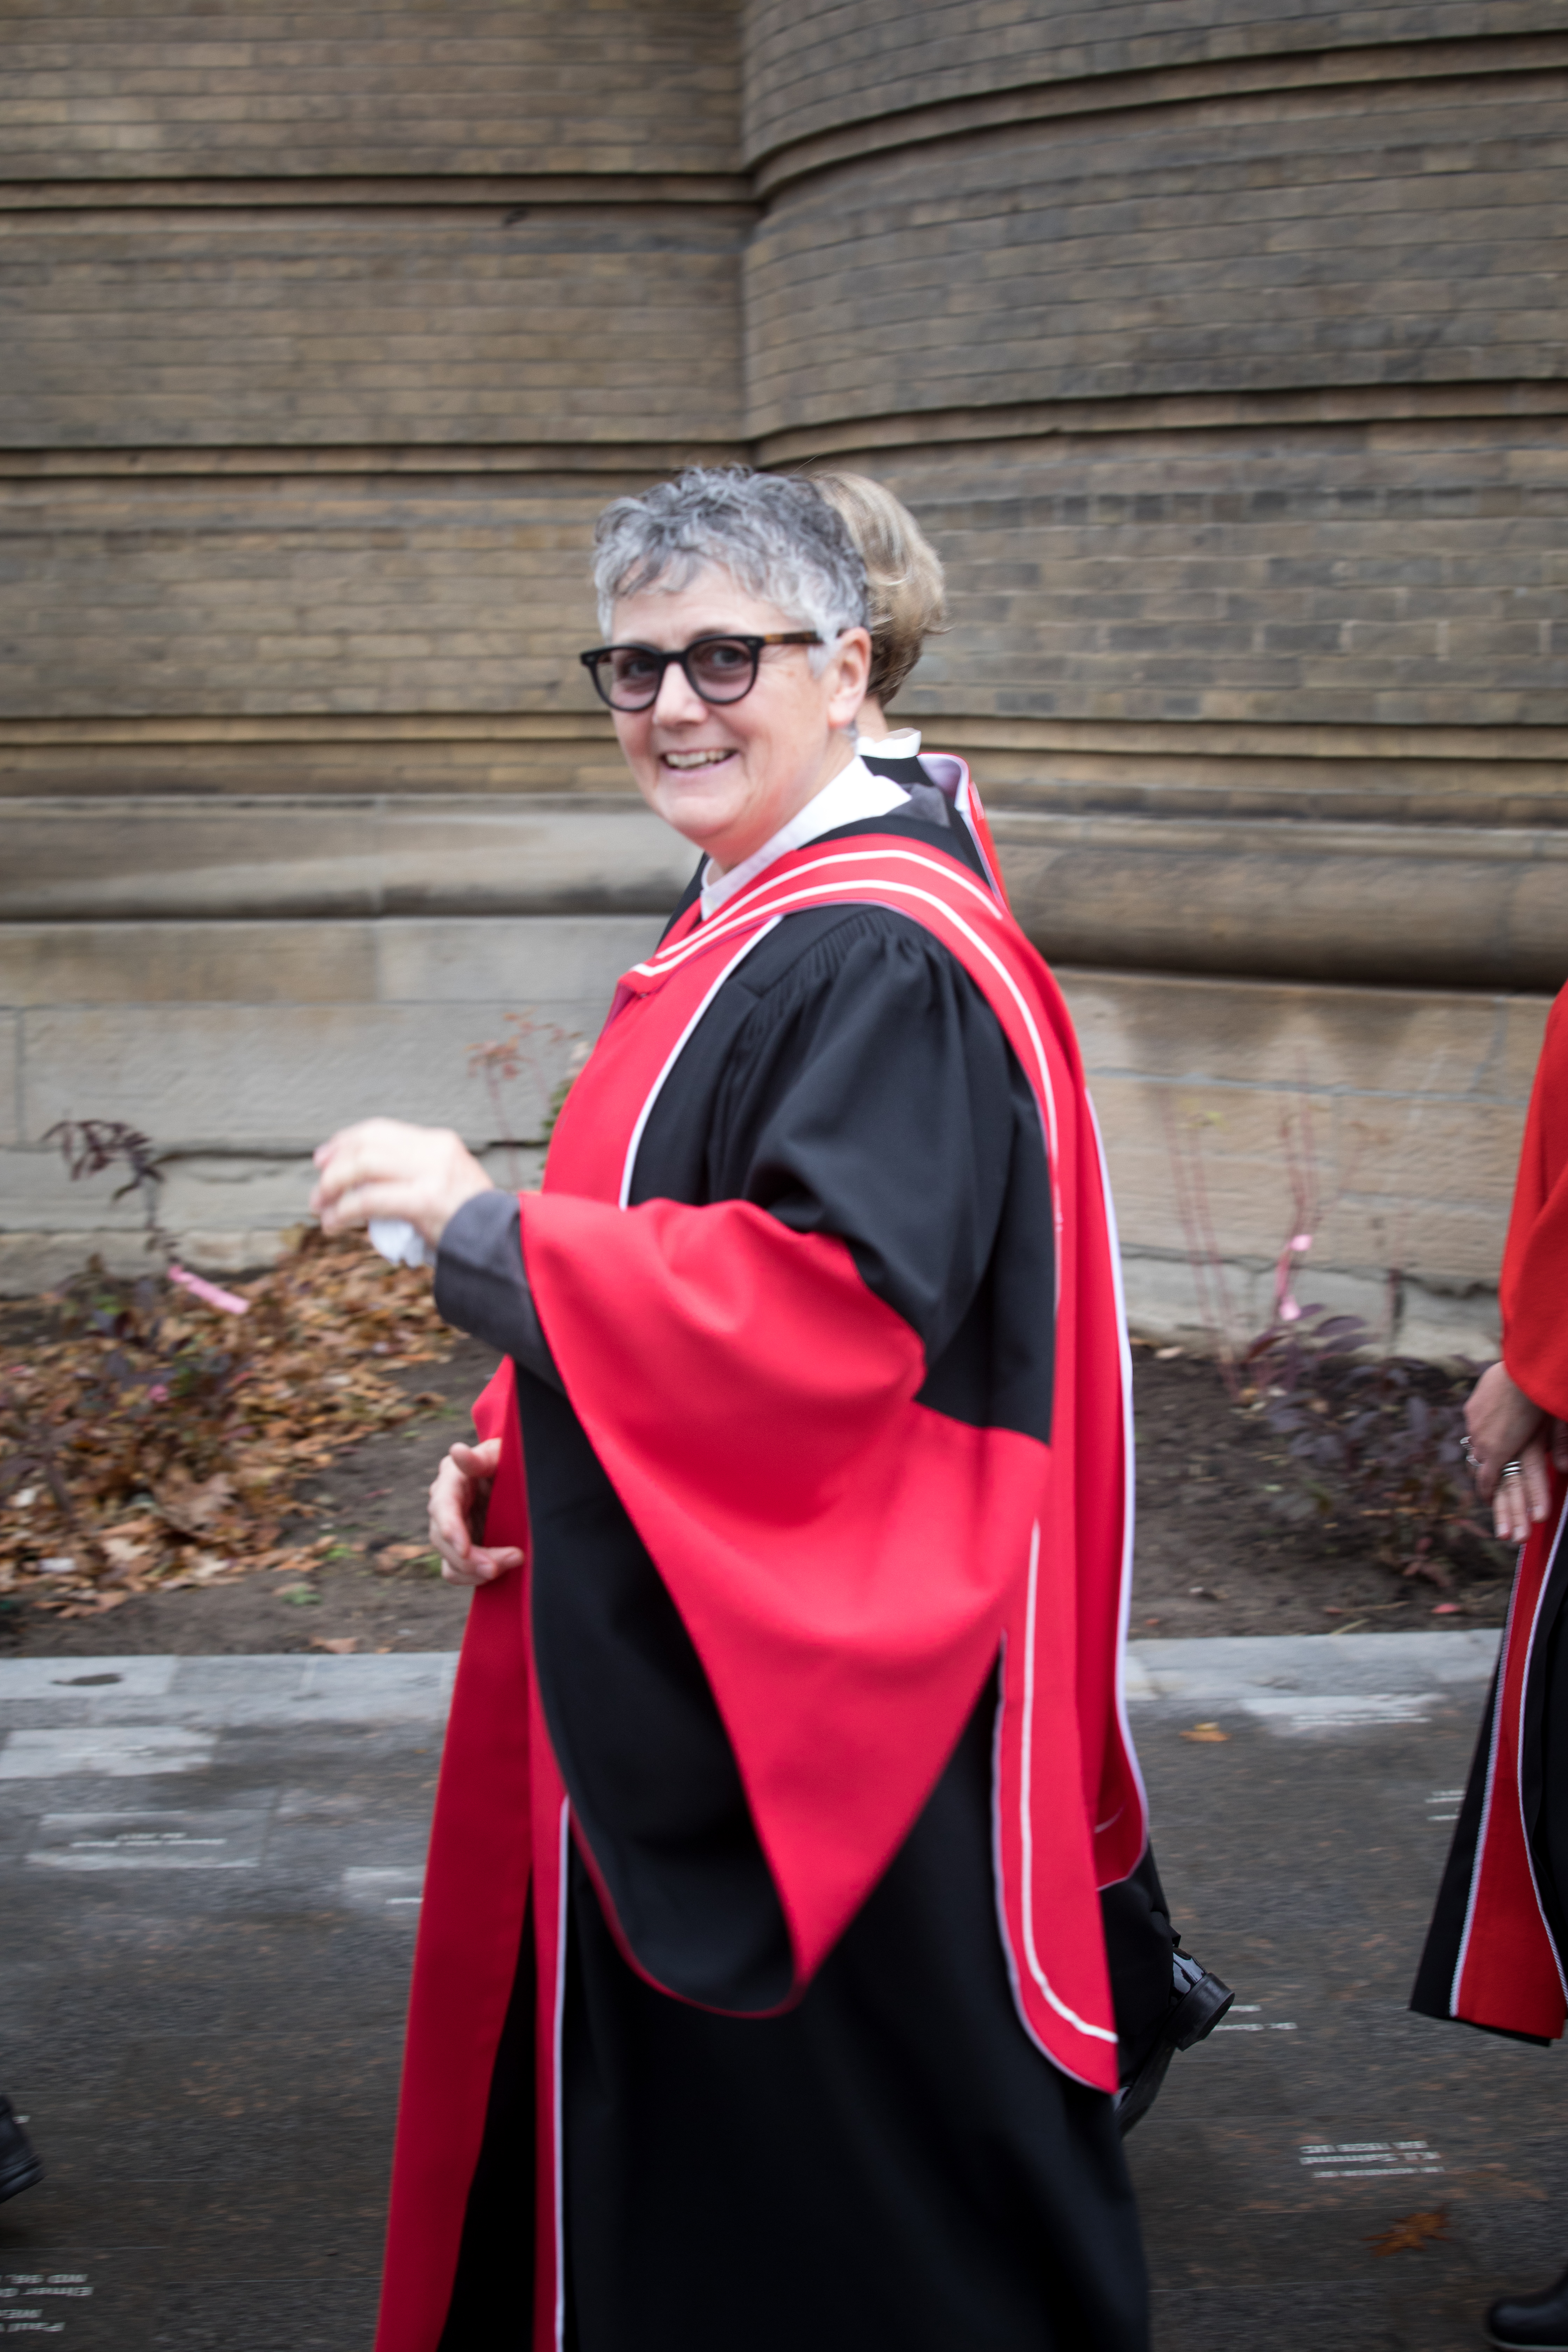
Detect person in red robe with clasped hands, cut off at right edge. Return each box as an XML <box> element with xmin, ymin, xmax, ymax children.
<box><xmin>1410</xmin><ymin>988</ymin><xmax>1568</xmax><ymax>2352</ymax></box>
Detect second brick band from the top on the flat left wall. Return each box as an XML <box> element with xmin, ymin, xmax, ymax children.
<box><xmin>0</xmin><ymin>211</ymin><xmax>750</xmax><ymax>451</ymax></box>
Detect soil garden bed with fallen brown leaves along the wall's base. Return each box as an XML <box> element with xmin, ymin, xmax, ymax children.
<box><xmin>0</xmin><ymin>1244</ymin><xmax>1509</xmax><ymax>1656</ymax></box>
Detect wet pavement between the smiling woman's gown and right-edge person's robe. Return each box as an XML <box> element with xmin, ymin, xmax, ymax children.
<box><xmin>1128</xmin><ymin>1634</ymin><xmax>1568</xmax><ymax>2352</ymax></box>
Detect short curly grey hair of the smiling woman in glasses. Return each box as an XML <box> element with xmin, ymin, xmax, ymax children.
<box><xmin>593</xmin><ymin>466</ymin><xmax>867</xmax><ymax>668</ymax></box>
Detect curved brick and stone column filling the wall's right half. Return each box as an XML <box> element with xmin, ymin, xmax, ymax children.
<box><xmin>745</xmin><ymin>0</ymin><xmax>1568</xmax><ymax>1352</ymax></box>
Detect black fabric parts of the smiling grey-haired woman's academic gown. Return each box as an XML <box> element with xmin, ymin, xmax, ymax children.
<box><xmin>437</xmin><ymin>811</ymin><xmax>1152</xmax><ymax>2352</ymax></box>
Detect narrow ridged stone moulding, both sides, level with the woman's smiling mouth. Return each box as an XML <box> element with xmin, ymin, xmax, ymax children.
<box><xmin>0</xmin><ymin>710</ymin><xmax>1568</xmax><ymax>830</ymax></box>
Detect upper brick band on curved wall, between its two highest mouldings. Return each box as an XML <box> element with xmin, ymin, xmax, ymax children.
<box><xmin>748</xmin><ymin>73</ymin><xmax>1568</xmax><ymax>433</ymax></box>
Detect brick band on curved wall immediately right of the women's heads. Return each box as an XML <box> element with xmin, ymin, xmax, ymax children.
<box><xmin>882</xmin><ymin>421</ymin><xmax>1568</xmax><ymax>732</ymax></box>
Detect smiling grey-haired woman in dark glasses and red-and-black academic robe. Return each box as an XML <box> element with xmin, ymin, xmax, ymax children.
<box><xmin>315</xmin><ymin>470</ymin><xmax>1147</xmax><ymax>2352</ymax></box>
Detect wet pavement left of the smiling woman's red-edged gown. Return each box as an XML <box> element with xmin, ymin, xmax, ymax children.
<box><xmin>0</xmin><ymin>1656</ymin><xmax>456</xmax><ymax>2352</ymax></box>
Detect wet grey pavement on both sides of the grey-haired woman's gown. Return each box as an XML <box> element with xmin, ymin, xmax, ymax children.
<box><xmin>0</xmin><ymin>1632</ymin><xmax>1568</xmax><ymax>2352</ymax></box>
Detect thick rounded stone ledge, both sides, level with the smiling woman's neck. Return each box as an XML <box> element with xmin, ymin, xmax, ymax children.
<box><xmin>0</xmin><ymin>795</ymin><xmax>1568</xmax><ymax>995</ymax></box>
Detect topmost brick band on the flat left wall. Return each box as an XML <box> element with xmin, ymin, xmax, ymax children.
<box><xmin>0</xmin><ymin>0</ymin><xmax>741</xmax><ymax>186</ymax></box>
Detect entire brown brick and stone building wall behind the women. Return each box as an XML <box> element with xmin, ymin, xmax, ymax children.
<box><xmin>0</xmin><ymin>0</ymin><xmax>1568</xmax><ymax>1352</ymax></box>
